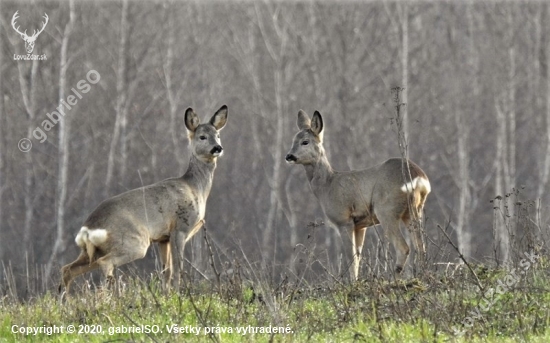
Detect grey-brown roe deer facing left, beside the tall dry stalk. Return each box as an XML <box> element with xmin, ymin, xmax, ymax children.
<box><xmin>286</xmin><ymin>110</ymin><xmax>430</xmax><ymax>280</ymax></box>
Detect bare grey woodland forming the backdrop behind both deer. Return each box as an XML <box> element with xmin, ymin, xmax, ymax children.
<box><xmin>0</xmin><ymin>0</ymin><xmax>550</xmax><ymax>288</ymax></box>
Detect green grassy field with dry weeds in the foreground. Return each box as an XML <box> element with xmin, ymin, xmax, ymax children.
<box><xmin>0</xmin><ymin>255</ymin><xmax>550</xmax><ymax>343</ymax></box>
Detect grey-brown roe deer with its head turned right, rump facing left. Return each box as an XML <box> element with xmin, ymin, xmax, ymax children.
<box><xmin>60</xmin><ymin>105</ymin><xmax>227</xmax><ymax>293</ymax></box>
